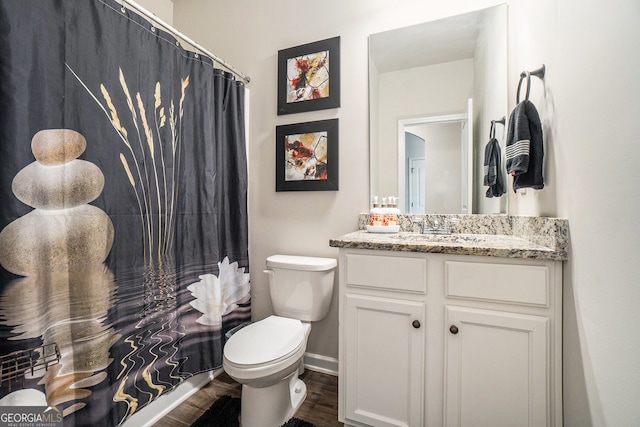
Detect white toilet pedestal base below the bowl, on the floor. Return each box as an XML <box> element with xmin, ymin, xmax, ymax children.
<box><xmin>240</xmin><ymin>370</ymin><xmax>307</xmax><ymax>427</ymax></box>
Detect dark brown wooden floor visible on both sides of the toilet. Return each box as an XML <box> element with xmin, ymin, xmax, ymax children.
<box><xmin>153</xmin><ymin>369</ymin><xmax>343</xmax><ymax>427</ymax></box>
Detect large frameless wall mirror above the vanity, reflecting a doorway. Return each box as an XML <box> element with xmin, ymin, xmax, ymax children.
<box><xmin>369</xmin><ymin>5</ymin><xmax>507</xmax><ymax>214</ymax></box>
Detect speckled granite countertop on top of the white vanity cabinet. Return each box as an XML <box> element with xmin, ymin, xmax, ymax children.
<box><xmin>329</xmin><ymin>217</ymin><xmax>568</xmax><ymax>261</ymax></box>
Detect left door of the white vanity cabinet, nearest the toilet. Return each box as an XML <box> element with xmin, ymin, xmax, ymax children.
<box><xmin>340</xmin><ymin>293</ymin><xmax>425</xmax><ymax>427</ymax></box>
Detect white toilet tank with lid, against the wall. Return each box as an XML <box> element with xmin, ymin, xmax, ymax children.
<box><xmin>265</xmin><ymin>255</ymin><xmax>338</xmax><ymax>322</ymax></box>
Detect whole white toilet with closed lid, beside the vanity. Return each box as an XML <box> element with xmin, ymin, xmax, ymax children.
<box><xmin>222</xmin><ymin>255</ymin><xmax>337</xmax><ymax>427</ymax></box>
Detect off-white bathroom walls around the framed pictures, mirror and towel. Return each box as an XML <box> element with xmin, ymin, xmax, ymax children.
<box><xmin>173</xmin><ymin>0</ymin><xmax>640</xmax><ymax>427</ymax></box>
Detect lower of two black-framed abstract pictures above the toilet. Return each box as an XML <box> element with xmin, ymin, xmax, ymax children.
<box><xmin>276</xmin><ymin>119</ymin><xmax>339</xmax><ymax>192</ymax></box>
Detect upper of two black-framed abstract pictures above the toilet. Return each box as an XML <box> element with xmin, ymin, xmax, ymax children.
<box><xmin>278</xmin><ymin>36</ymin><xmax>340</xmax><ymax>115</ymax></box>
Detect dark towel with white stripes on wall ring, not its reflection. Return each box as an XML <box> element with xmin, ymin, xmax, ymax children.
<box><xmin>506</xmin><ymin>100</ymin><xmax>544</xmax><ymax>191</ymax></box>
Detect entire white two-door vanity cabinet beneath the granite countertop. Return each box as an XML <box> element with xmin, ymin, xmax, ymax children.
<box><xmin>339</xmin><ymin>248</ymin><xmax>562</xmax><ymax>427</ymax></box>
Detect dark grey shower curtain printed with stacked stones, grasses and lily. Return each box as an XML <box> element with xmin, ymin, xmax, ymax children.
<box><xmin>0</xmin><ymin>0</ymin><xmax>250</xmax><ymax>426</ymax></box>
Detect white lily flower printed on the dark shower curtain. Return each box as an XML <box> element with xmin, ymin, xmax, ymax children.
<box><xmin>187</xmin><ymin>257</ymin><xmax>251</xmax><ymax>326</ymax></box>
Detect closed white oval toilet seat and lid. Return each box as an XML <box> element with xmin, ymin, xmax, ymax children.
<box><xmin>223</xmin><ymin>316</ymin><xmax>309</xmax><ymax>382</ymax></box>
